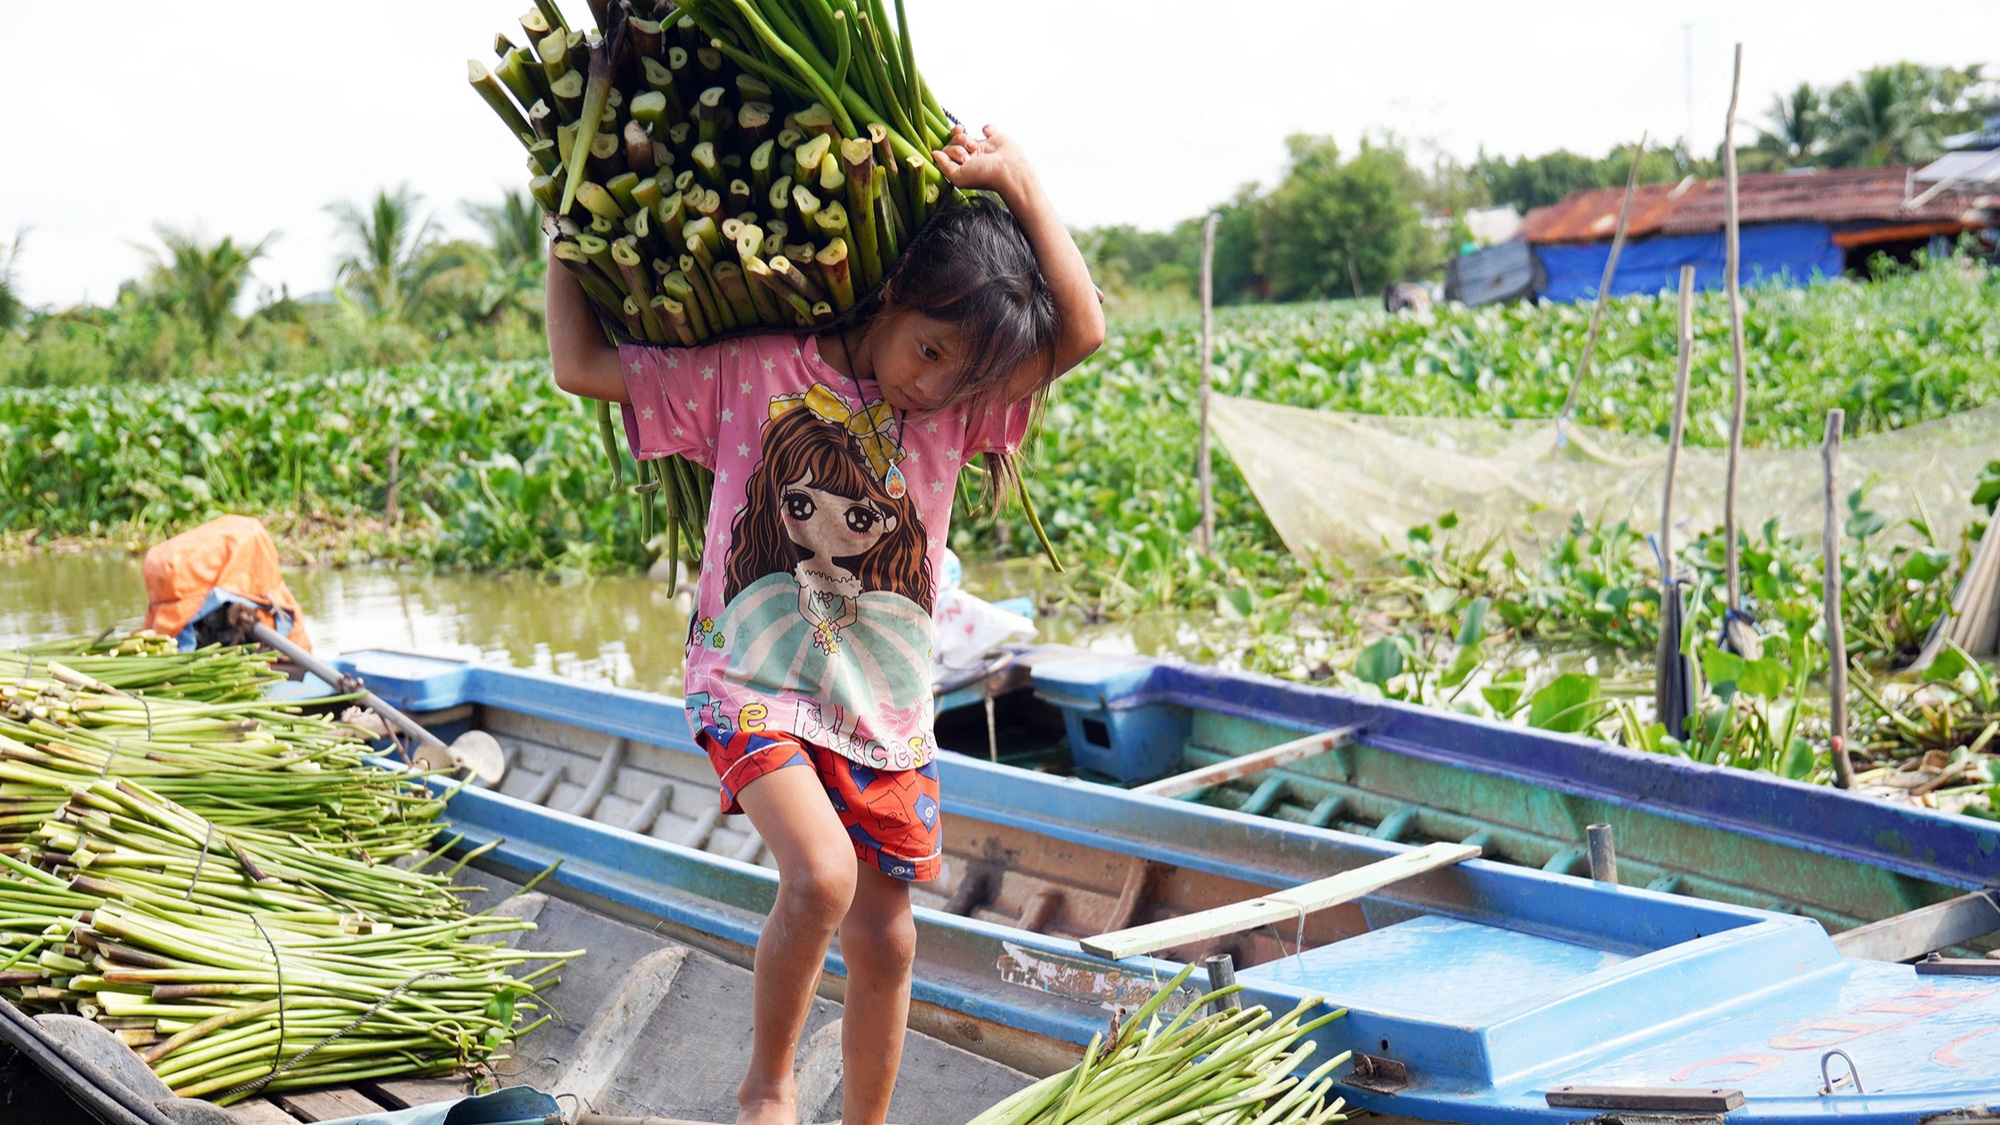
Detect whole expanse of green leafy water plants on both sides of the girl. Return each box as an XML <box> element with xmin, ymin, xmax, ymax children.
<box><xmin>0</xmin><ymin>242</ymin><xmax>2000</xmax><ymax>800</ymax></box>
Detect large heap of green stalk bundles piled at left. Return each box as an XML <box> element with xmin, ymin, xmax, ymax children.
<box><xmin>0</xmin><ymin>636</ymin><xmax>580</xmax><ymax>1105</ymax></box>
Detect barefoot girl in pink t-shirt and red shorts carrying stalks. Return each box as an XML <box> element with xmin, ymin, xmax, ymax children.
<box><xmin>548</xmin><ymin>128</ymin><xmax>1104</xmax><ymax>1125</ymax></box>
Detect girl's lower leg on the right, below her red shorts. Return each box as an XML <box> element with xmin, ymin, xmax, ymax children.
<box><xmin>840</xmin><ymin>863</ymin><xmax>916</xmax><ymax>1125</ymax></box>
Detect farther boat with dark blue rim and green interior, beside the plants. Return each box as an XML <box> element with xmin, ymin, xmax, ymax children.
<box><xmin>940</xmin><ymin>647</ymin><xmax>2000</xmax><ymax>944</ymax></box>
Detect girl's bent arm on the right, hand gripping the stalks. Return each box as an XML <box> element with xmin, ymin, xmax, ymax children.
<box><xmin>932</xmin><ymin>126</ymin><xmax>1104</xmax><ymax>398</ymax></box>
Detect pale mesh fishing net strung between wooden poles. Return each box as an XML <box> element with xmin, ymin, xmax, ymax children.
<box><xmin>1210</xmin><ymin>394</ymin><xmax>2000</xmax><ymax>560</ymax></box>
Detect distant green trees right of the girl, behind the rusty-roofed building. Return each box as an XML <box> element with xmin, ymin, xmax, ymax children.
<box><xmin>1078</xmin><ymin>62</ymin><xmax>2000</xmax><ymax>308</ymax></box>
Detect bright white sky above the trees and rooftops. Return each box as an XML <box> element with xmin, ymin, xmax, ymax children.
<box><xmin>0</xmin><ymin>0</ymin><xmax>2000</xmax><ymax>304</ymax></box>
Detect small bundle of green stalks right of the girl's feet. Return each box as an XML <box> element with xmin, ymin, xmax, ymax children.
<box><xmin>970</xmin><ymin>965</ymin><xmax>1348</xmax><ymax>1125</ymax></box>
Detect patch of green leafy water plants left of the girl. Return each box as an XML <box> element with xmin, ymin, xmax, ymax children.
<box><xmin>0</xmin><ymin>362</ymin><xmax>648</xmax><ymax>571</ymax></box>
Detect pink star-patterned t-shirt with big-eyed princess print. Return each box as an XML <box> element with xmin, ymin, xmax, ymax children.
<box><xmin>618</xmin><ymin>334</ymin><xmax>1028</xmax><ymax>769</ymax></box>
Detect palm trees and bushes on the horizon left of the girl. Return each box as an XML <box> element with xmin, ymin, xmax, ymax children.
<box><xmin>0</xmin><ymin>186</ymin><xmax>546</xmax><ymax>386</ymax></box>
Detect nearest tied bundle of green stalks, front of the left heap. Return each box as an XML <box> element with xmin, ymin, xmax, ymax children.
<box><xmin>0</xmin><ymin>781</ymin><xmax>580</xmax><ymax>1103</ymax></box>
